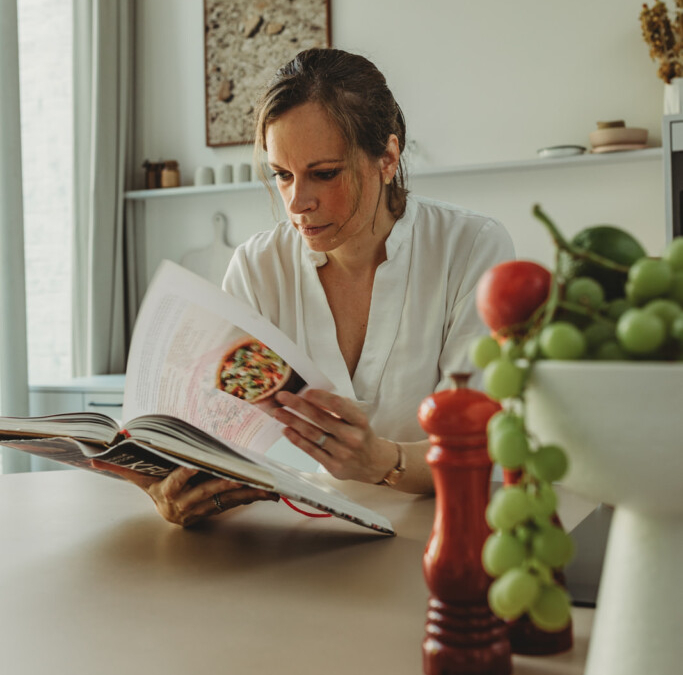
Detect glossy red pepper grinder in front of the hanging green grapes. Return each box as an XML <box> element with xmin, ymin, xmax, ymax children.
<box><xmin>418</xmin><ymin>373</ymin><xmax>512</xmax><ymax>675</ymax></box>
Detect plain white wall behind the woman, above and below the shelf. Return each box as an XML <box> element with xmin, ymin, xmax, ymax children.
<box><xmin>136</xmin><ymin>0</ymin><xmax>665</xmax><ymax>282</ymax></box>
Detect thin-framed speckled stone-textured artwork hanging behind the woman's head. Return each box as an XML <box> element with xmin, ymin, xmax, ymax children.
<box><xmin>204</xmin><ymin>0</ymin><xmax>331</xmax><ymax>147</ymax></box>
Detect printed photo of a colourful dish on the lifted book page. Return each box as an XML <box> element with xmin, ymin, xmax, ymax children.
<box><xmin>216</xmin><ymin>335</ymin><xmax>306</xmax><ymax>408</ymax></box>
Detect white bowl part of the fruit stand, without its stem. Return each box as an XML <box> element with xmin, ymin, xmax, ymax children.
<box><xmin>528</xmin><ymin>361</ymin><xmax>683</xmax><ymax>516</ymax></box>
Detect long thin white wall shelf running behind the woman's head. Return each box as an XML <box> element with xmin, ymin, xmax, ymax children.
<box><xmin>124</xmin><ymin>148</ymin><xmax>662</xmax><ymax>200</ymax></box>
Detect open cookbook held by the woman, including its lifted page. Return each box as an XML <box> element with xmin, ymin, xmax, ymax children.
<box><xmin>0</xmin><ymin>261</ymin><xmax>393</xmax><ymax>534</ymax></box>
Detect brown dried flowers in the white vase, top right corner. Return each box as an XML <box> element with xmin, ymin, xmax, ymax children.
<box><xmin>640</xmin><ymin>0</ymin><xmax>683</xmax><ymax>84</ymax></box>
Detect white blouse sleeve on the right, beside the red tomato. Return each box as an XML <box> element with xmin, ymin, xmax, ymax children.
<box><xmin>437</xmin><ymin>220</ymin><xmax>515</xmax><ymax>389</ymax></box>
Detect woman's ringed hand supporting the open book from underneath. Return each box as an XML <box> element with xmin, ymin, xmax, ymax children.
<box><xmin>92</xmin><ymin>460</ymin><xmax>280</xmax><ymax>527</ymax></box>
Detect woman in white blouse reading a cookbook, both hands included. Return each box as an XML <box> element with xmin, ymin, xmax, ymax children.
<box><xmin>107</xmin><ymin>49</ymin><xmax>514</xmax><ymax>525</ymax></box>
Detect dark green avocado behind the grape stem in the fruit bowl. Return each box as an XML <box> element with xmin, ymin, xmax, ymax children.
<box><xmin>560</xmin><ymin>225</ymin><xmax>647</xmax><ymax>300</ymax></box>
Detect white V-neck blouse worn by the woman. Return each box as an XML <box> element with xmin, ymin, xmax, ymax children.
<box><xmin>223</xmin><ymin>195</ymin><xmax>514</xmax><ymax>442</ymax></box>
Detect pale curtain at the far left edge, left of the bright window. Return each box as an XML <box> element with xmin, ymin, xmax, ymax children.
<box><xmin>0</xmin><ymin>2</ymin><xmax>30</xmax><ymax>473</ymax></box>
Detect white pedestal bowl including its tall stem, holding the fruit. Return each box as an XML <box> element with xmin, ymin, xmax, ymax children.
<box><xmin>526</xmin><ymin>361</ymin><xmax>683</xmax><ymax>675</ymax></box>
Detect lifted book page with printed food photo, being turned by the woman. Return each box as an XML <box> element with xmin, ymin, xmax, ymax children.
<box><xmin>123</xmin><ymin>261</ymin><xmax>332</xmax><ymax>453</ymax></box>
